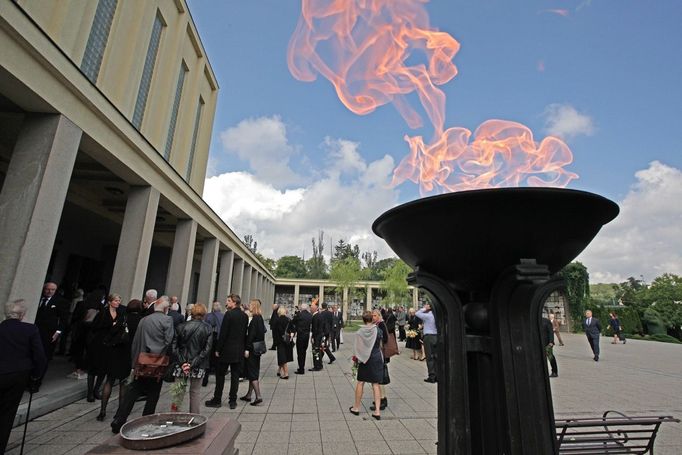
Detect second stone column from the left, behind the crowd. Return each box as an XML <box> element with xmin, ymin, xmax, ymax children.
<box><xmin>111</xmin><ymin>186</ymin><xmax>160</xmax><ymax>302</ymax></box>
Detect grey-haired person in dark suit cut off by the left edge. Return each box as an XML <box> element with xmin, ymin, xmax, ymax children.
<box><xmin>0</xmin><ymin>300</ymin><xmax>47</xmax><ymax>453</ymax></box>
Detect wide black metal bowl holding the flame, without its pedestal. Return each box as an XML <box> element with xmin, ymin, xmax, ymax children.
<box><xmin>372</xmin><ymin>188</ymin><xmax>619</xmax><ymax>291</ymax></box>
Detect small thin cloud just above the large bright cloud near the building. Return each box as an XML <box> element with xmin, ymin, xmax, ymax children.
<box><xmin>220</xmin><ymin>116</ymin><xmax>302</xmax><ymax>188</ymax></box>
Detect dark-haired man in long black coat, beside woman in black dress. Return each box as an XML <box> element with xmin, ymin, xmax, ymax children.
<box><xmin>205</xmin><ymin>294</ymin><xmax>249</xmax><ymax>409</ymax></box>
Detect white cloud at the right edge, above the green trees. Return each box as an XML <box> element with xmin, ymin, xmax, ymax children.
<box><xmin>578</xmin><ymin>161</ymin><xmax>682</xmax><ymax>283</ymax></box>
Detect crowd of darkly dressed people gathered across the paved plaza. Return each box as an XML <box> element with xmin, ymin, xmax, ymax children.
<box><xmin>5</xmin><ymin>282</ymin><xmax>612</xmax><ymax>452</ymax></box>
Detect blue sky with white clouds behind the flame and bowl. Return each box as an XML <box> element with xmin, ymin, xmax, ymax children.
<box><xmin>189</xmin><ymin>0</ymin><xmax>682</xmax><ymax>282</ymax></box>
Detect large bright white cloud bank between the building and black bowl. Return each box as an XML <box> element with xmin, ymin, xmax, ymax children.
<box><xmin>204</xmin><ymin>136</ymin><xmax>398</xmax><ymax>259</ymax></box>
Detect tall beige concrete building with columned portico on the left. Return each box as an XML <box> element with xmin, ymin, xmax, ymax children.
<box><xmin>0</xmin><ymin>0</ymin><xmax>275</xmax><ymax>320</ymax></box>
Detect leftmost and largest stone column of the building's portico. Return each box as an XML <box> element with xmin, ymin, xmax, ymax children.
<box><xmin>0</xmin><ymin>114</ymin><xmax>82</xmax><ymax>322</ymax></box>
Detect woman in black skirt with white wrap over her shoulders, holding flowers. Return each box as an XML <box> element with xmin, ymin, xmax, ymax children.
<box><xmin>349</xmin><ymin>311</ymin><xmax>384</xmax><ymax>420</ymax></box>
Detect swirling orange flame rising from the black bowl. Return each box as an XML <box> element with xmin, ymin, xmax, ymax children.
<box><xmin>287</xmin><ymin>0</ymin><xmax>577</xmax><ymax>194</ymax></box>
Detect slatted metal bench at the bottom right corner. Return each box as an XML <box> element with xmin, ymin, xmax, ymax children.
<box><xmin>555</xmin><ymin>411</ymin><xmax>680</xmax><ymax>455</ymax></box>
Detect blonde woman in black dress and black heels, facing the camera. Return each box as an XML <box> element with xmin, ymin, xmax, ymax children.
<box><xmin>90</xmin><ymin>294</ymin><xmax>130</xmax><ymax>421</ymax></box>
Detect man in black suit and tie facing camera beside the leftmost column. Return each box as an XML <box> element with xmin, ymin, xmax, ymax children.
<box><xmin>35</xmin><ymin>281</ymin><xmax>69</xmax><ymax>362</ymax></box>
